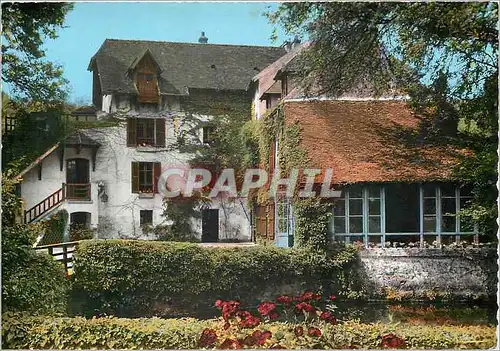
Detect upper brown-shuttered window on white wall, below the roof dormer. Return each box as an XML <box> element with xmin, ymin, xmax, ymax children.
<box><xmin>127</xmin><ymin>118</ymin><xmax>165</xmax><ymax>147</ymax></box>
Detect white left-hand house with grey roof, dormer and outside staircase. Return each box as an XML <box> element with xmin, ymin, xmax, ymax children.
<box><xmin>19</xmin><ymin>36</ymin><xmax>285</xmax><ymax>241</ymax></box>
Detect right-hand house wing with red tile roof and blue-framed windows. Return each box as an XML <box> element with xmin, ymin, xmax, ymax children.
<box><xmin>252</xmin><ymin>46</ymin><xmax>478</xmax><ymax>247</ymax></box>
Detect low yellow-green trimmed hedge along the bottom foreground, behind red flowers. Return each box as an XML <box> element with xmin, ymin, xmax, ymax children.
<box><xmin>2</xmin><ymin>315</ymin><xmax>496</xmax><ymax>350</ymax></box>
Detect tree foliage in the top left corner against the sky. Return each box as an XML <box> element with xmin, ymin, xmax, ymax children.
<box><xmin>2</xmin><ymin>3</ymin><xmax>73</xmax><ymax>103</ymax></box>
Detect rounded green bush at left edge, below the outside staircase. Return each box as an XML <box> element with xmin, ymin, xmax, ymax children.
<box><xmin>2</xmin><ymin>226</ymin><xmax>68</xmax><ymax>314</ymax></box>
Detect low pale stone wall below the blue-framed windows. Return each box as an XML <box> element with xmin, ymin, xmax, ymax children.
<box><xmin>360</xmin><ymin>248</ymin><xmax>497</xmax><ymax>300</ymax></box>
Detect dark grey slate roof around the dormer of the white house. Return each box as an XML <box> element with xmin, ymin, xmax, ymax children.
<box><xmin>89</xmin><ymin>39</ymin><xmax>286</xmax><ymax>95</ymax></box>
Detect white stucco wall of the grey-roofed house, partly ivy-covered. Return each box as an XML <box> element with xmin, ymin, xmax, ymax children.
<box><xmin>21</xmin><ymin>98</ymin><xmax>251</xmax><ymax>240</ymax></box>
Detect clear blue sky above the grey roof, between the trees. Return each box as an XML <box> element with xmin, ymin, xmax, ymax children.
<box><xmin>40</xmin><ymin>2</ymin><xmax>286</xmax><ymax>103</ymax></box>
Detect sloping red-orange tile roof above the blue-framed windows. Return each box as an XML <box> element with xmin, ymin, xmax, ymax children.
<box><xmin>284</xmin><ymin>100</ymin><xmax>468</xmax><ymax>184</ymax></box>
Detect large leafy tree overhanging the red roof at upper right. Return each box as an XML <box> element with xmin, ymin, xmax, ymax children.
<box><xmin>266</xmin><ymin>2</ymin><xmax>498</xmax><ymax>239</ymax></box>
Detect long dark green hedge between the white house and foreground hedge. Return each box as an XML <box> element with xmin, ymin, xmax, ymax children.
<box><xmin>72</xmin><ymin>240</ymin><xmax>360</xmax><ymax>317</ymax></box>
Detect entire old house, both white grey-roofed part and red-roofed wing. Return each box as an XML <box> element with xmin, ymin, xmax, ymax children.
<box><xmin>15</xmin><ymin>36</ymin><xmax>478</xmax><ymax>247</ymax></box>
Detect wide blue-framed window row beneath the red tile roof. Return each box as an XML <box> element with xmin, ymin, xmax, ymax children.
<box><xmin>330</xmin><ymin>183</ymin><xmax>477</xmax><ymax>245</ymax></box>
